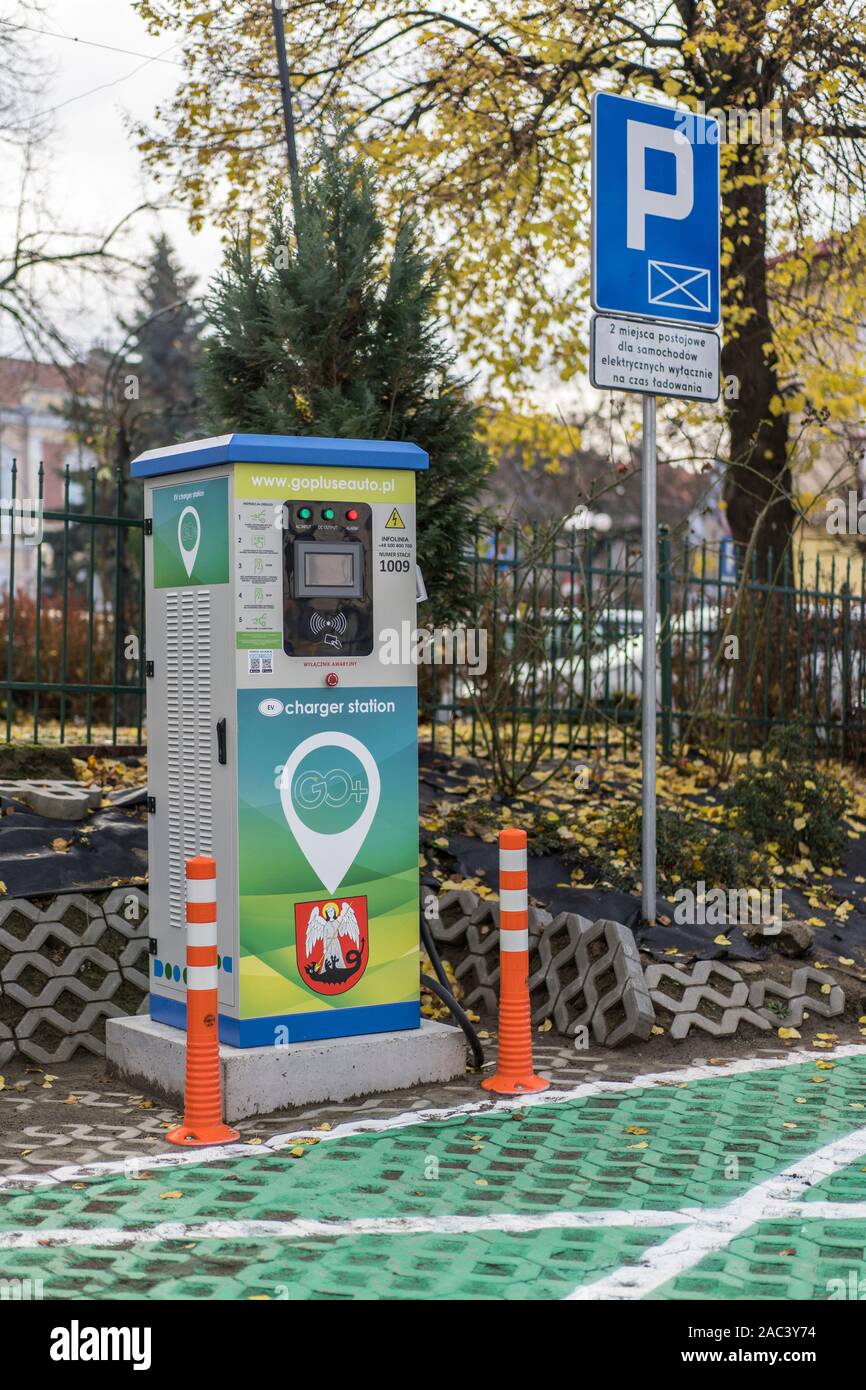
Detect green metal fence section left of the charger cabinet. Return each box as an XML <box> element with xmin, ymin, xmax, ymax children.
<box><xmin>0</xmin><ymin>464</ymin><xmax>145</xmax><ymax>745</ymax></box>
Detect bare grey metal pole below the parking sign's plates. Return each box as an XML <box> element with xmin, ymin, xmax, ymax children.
<box><xmin>641</xmin><ymin>396</ymin><xmax>657</xmax><ymax>924</ymax></box>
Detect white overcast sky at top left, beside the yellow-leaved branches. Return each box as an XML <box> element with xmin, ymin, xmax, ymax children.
<box><xmin>0</xmin><ymin>0</ymin><xmax>226</xmax><ymax>352</ymax></box>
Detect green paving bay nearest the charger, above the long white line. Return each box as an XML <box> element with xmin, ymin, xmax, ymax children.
<box><xmin>0</xmin><ymin>1058</ymin><xmax>866</xmax><ymax>1230</ymax></box>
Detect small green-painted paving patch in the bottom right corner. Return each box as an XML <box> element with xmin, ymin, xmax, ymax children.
<box><xmin>648</xmin><ymin>1219</ymin><xmax>866</xmax><ymax>1301</ymax></box>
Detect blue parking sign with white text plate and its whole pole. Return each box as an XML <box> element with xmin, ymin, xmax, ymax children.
<box><xmin>589</xmin><ymin>92</ymin><xmax>721</xmax><ymax>926</ymax></box>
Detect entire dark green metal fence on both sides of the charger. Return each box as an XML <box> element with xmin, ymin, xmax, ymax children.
<box><xmin>0</xmin><ymin>483</ymin><xmax>866</xmax><ymax>760</ymax></box>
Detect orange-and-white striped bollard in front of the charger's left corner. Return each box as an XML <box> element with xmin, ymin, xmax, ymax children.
<box><xmin>165</xmin><ymin>855</ymin><xmax>239</xmax><ymax>1148</ymax></box>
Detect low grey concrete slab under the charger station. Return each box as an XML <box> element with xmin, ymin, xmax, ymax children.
<box><xmin>106</xmin><ymin>1016</ymin><xmax>466</xmax><ymax>1125</ymax></box>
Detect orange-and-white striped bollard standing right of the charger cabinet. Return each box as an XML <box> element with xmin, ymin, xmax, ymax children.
<box><xmin>481</xmin><ymin>830</ymin><xmax>550</xmax><ymax>1095</ymax></box>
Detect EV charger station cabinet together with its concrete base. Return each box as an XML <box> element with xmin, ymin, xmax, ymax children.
<box><xmin>108</xmin><ymin>434</ymin><xmax>463</xmax><ymax>1118</ymax></box>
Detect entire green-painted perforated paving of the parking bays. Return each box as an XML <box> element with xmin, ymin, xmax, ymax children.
<box><xmin>0</xmin><ymin>1055</ymin><xmax>866</xmax><ymax>1298</ymax></box>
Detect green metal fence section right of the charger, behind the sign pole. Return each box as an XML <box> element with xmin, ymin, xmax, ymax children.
<box><xmin>423</xmin><ymin>527</ymin><xmax>866</xmax><ymax>760</ymax></box>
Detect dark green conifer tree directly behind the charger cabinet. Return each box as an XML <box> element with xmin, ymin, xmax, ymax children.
<box><xmin>202</xmin><ymin>132</ymin><xmax>487</xmax><ymax>621</ymax></box>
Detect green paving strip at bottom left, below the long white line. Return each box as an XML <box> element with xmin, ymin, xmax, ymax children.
<box><xmin>3</xmin><ymin>1226</ymin><xmax>681</xmax><ymax>1301</ymax></box>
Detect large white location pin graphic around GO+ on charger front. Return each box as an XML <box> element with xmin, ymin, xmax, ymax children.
<box><xmin>279</xmin><ymin>734</ymin><xmax>382</xmax><ymax>892</ymax></box>
